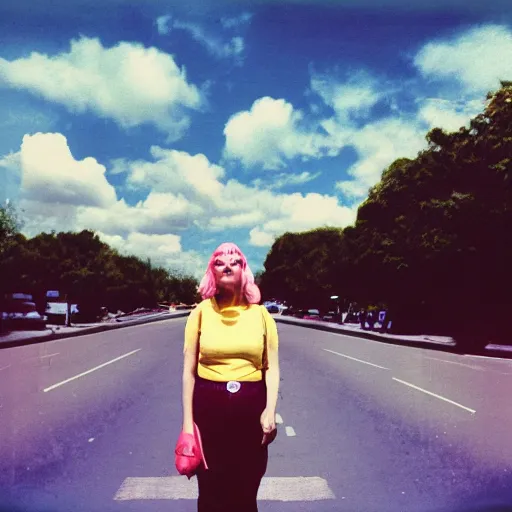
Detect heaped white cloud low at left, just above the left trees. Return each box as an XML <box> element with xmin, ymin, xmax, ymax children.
<box><xmin>4</xmin><ymin>133</ymin><xmax>202</xmax><ymax>244</ymax></box>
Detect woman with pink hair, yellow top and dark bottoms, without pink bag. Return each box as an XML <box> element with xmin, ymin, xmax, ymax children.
<box><xmin>183</xmin><ymin>243</ymin><xmax>279</xmax><ymax>512</ymax></box>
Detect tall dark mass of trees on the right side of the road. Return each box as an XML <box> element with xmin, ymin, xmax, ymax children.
<box><xmin>261</xmin><ymin>82</ymin><xmax>512</xmax><ymax>348</ymax></box>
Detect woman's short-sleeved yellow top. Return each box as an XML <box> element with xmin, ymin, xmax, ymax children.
<box><xmin>184</xmin><ymin>298</ymin><xmax>278</xmax><ymax>382</ymax></box>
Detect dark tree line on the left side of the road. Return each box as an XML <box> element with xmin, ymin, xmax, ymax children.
<box><xmin>0</xmin><ymin>212</ymin><xmax>198</xmax><ymax>320</ymax></box>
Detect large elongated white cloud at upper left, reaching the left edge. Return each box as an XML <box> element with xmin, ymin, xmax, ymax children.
<box><xmin>0</xmin><ymin>37</ymin><xmax>203</xmax><ymax>139</ymax></box>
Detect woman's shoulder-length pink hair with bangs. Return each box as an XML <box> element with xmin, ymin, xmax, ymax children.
<box><xmin>199</xmin><ymin>242</ymin><xmax>261</xmax><ymax>304</ymax></box>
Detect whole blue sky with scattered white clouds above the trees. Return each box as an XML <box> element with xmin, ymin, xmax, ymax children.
<box><xmin>0</xmin><ymin>0</ymin><xmax>512</xmax><ymax>277</ymax></box>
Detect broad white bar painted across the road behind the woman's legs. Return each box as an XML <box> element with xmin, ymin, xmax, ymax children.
<box><xmin>114</xmin><ymin>476</ymin><xmax>336</xmax><ymax>501</ymax></box>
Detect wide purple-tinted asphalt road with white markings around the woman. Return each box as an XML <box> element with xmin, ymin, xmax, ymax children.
<box><xmin>0</xmin><ymin>318</ymin><xmax>512</xmax><ymax>512</ymax></box>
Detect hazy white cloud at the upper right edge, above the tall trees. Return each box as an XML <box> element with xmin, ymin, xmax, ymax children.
<box><xmin>414</xmin><ymin>25</ymin><xmax>512</xmax><ymax>94</ymax></box>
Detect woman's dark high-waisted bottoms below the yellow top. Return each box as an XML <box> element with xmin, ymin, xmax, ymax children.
<box><xmin>193</xmin><ymin>377</ymin><xmax>268</xmax><ymax>512</ymax></box>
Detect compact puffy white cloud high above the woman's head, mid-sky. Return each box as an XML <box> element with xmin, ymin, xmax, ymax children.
<box><xmin>224</xmin><ymin>96</ymin><xmax>323</xmax><ymax>169</ymax></box>
